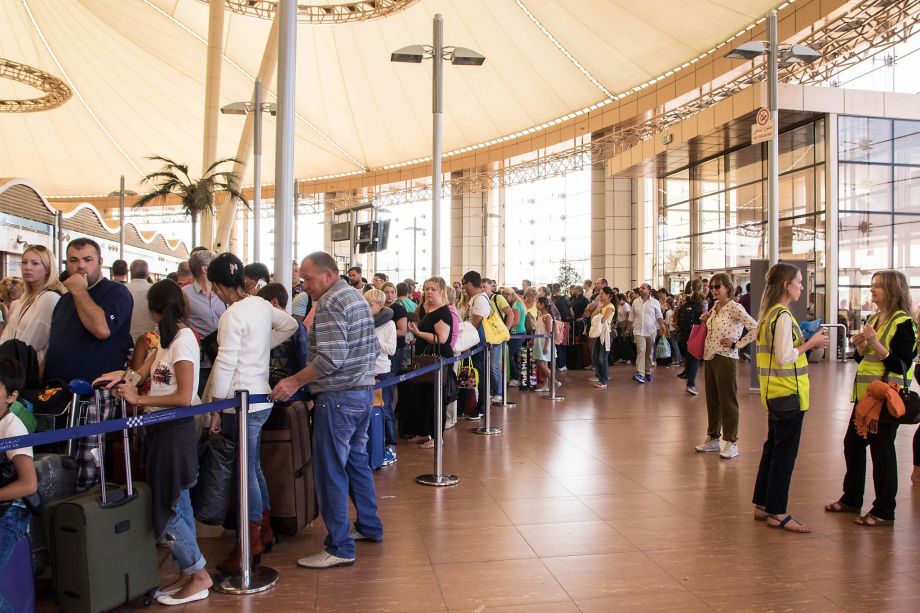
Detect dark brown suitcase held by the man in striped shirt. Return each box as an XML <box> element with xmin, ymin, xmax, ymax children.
<box><xmin>260</xmin><ymin>402</ymin><xmax>318</xmax><ymax>536</ymax></box>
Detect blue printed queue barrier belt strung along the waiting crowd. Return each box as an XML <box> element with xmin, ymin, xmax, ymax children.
<box><xmin>0</xmin><ymin>345</ymin><xmax>492</xmax><ymax>453</ymax></box>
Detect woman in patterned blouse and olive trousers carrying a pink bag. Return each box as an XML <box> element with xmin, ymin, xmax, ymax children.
<box><xmin>696</xmin><ymin>272</ymin><xmax>757</xmax><ymax>460</ymax></box>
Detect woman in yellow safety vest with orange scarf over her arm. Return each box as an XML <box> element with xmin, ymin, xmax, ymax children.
<box><xmin>824</xmin><ymin>270</ymin><xmax>917</xmax><ymax>527</ymax></box>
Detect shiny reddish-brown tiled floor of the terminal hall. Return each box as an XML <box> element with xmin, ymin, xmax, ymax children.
<box><xmin>36</xmin><ymin>356</ymin><xmax>920</xmax><ymax>613</ymax></box>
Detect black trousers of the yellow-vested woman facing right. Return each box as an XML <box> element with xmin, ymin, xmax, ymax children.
<box><xmin>753</xmin><ymin>411</ymin><xmax>805</xmax><ymax>515</ymax></box>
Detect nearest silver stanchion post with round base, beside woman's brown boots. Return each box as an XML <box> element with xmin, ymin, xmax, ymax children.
<box><xmin>214</xmin><ymin>390</ymin><xmax>278</xmax><ymax>594</ymax></box>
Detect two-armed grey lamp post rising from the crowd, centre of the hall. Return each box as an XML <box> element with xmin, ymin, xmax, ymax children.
<box><xmin>390</xmin><ymin>13</ymin><xmax>486</xmax><ymax>276</ymax></box>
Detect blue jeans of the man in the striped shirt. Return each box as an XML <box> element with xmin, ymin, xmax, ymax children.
<box><xmin>313</xmin><ymin>389</ymin><xmax>383</xmax><ymax>559</ymax></box>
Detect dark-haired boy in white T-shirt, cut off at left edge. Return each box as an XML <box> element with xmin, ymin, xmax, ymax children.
<box><xmin>0</xmin><ymin>357</ymin><xmax>38</xmax><ymax>611</ymax></box>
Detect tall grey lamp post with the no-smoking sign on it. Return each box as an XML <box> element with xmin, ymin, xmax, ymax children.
<box><xmin>725</xmin><ymin>9</ymin><xmax>821</xmax><ymax>266</ymax></box>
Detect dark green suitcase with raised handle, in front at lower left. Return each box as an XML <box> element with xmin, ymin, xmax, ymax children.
<box><xmin>44</xmin><ymin>391</ymin><xmax>160</xmax><ymax>613</ymax></box>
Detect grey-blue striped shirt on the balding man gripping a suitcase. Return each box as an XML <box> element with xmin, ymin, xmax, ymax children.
<box><xmin>308</xmin><ymin>279</ymin><xmax>378</xmax><ymax>393</ymax></box>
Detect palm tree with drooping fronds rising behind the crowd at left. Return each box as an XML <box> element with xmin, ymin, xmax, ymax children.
<box><xmin>134</xmin><ymin>155</ymin><xmax>249</xmax><ymax>248</ymax></box>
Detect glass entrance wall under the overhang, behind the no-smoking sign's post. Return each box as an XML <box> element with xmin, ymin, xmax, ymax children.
<box><xmin>657</xmin><ymin>119</ymin><xmax>825</xmax><ymax>317</ymax></box>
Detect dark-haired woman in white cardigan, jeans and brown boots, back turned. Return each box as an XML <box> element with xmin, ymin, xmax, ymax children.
<box><xmin>206</xmin><ymin>253</ymin><xmax>297</xmax><ymax>574</ymax></box>
